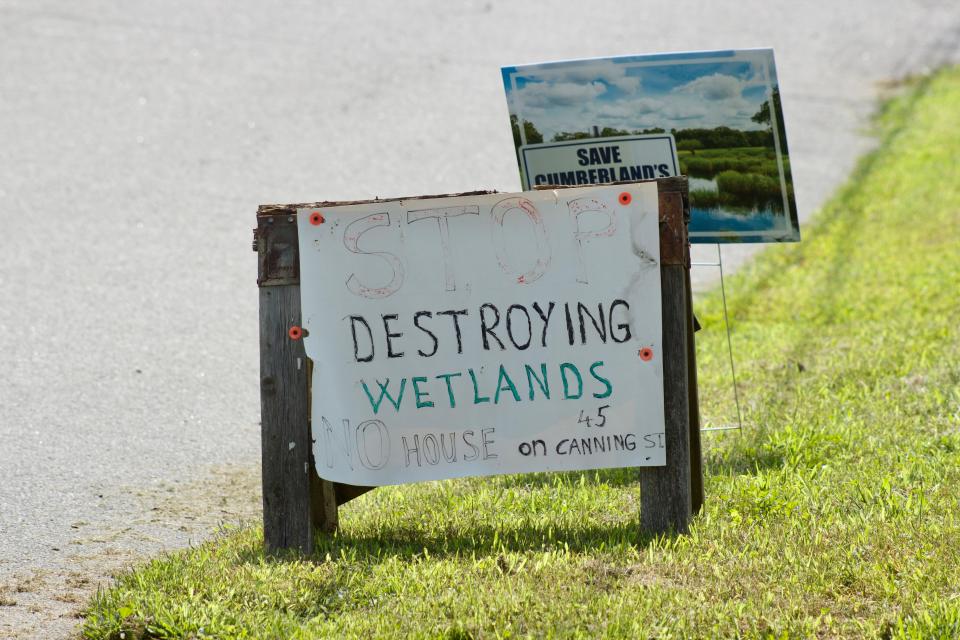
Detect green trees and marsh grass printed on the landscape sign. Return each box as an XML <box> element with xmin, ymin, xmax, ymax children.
<box><xmin>510</xmin><ymin>87</ymin><xmax>793</xmax><ymax>213</ymax></box>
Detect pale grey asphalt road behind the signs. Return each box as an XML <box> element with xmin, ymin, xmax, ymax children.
<box><xmin>0</xmin><ymin>0</ymin><xmax>960</xmax><ymax>637</ymax></box>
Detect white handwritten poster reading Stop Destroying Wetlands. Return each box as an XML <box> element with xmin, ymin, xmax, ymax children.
<box><xmin>298</xmin><ymin>183</ymin><xmax>665</xmax><ymax>486</ymax></box>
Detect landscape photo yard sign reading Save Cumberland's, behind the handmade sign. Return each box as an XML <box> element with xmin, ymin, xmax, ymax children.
<box><xmin>502</xmin><ymin>49</ymin><xmax>800</xmax><ymax>243</ymax></box>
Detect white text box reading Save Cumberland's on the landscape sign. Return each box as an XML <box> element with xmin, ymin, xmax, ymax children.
<box><xmin>520</xmin><ymin>133</ymin><xmax>680</xmax><ymax>189</ymax></box>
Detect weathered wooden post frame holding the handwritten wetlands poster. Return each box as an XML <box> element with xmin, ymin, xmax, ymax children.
<box><xmin>253</xmin><ymin>176</ymin><xmax>704</xmax><ymax>554</ymax></box>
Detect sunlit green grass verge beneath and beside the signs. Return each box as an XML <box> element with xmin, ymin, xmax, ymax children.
<box><xmin>84</xmin><ymin>69</ymin><xmax>960</xmax><ymax>639</ymax></box>
